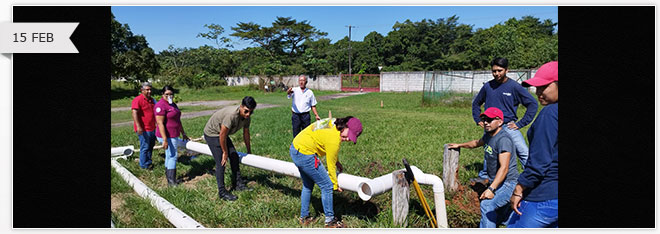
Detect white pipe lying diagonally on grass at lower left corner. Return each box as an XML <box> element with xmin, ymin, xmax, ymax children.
<box><xmin>110</xmin><ymin>159</ymin><xmax>204</xmax><ymax>228</ymax></box>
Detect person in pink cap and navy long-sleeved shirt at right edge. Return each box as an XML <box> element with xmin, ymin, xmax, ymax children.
<box><xmin>507</xmin><ymin>61</ymin><xmax>559</xmax><ymax>228</ymax></box>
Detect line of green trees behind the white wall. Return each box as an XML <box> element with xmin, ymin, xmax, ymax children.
<box><xmin>111</xmin><ymin>15</ymin><xmax>558</xmax><ymax>88</ymax></box>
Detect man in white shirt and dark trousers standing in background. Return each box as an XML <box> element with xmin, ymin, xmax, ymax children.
<box><xmin>286</xmin><ymin>75</ymin><xmax>321</xmax><ymax>137</ymax></box>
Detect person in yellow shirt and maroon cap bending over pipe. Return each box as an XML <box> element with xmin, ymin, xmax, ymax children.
<box><xmin>289</xmin><ymin>116</ymin><xmax>362</xmax><ymax>228</ymax></box>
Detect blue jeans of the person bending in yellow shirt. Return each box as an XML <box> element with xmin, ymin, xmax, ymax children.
<box><xmin>289</xmin><ymin>145</ymin><xmax>335</xmax><ymax>223</ymax></box>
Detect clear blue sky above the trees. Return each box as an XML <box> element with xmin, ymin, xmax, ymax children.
<box><xmin>112</xmin><ymin>6</ymin><xmax>558</xmax><ymax>53</ymax></box>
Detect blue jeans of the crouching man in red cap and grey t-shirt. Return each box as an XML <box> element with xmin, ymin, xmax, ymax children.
<box><xmin>479</xmin><ymin>181</ymin><xmax>516</xmax><ymax>228</ymax></box>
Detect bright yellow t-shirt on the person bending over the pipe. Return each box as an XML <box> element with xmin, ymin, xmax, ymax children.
<box><xmin>293</xmin><ymin>118</ymin><xmax>341</xmax><ymax>190</ymax></box>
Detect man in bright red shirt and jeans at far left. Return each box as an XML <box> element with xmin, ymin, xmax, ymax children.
<box><xmin>131</xmin><ymin>82</ymin><xmax>156</xmax><ymax>170</ymax></box>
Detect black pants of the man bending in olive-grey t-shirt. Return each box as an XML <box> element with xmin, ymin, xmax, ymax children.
<box><xmin>204</xmin><ymin>134</ymin><xmax>240</xmax><ymax>191</ymax></box>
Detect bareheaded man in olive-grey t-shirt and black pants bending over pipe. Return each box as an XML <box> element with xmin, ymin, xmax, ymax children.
<box><xmin>204</xmin><ymin>96</ymin><xmax>257</xmax><ymax>201</ymax></box>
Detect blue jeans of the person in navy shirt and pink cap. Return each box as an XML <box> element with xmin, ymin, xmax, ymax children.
<box><xmin>507</xmin><ymin>199</ymin><xmax>559</xmax><ymax>228</ymax></box>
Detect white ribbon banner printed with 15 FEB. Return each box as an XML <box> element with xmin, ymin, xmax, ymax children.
<box><xmin>0</xmin><ymin>22</ymin><xmax>79</xmax><ymax>53</ymax></box>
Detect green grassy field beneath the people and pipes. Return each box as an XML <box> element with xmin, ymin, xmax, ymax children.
<box><xmin>111</xmin><ymin>92</ymin><xmax>528</xmax><ymax>228</ymax></box>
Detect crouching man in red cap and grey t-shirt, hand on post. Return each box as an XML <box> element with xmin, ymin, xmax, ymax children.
<box><xmin>449</xmin><ymin>107</ymin><xmax>518</xmax><ymax>228</ymax></box>
